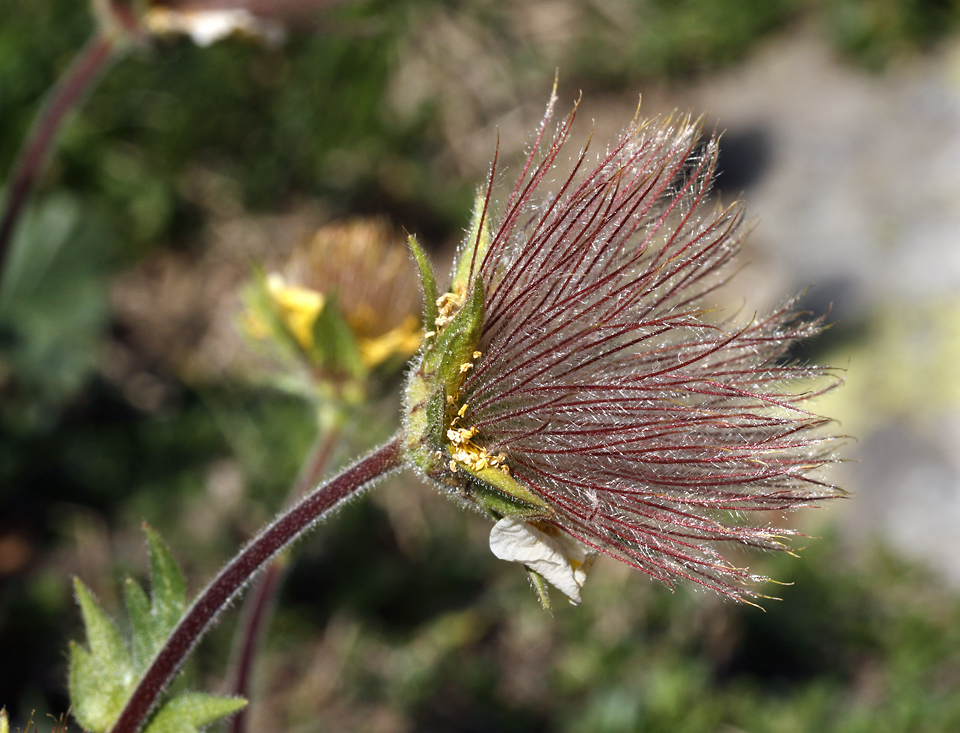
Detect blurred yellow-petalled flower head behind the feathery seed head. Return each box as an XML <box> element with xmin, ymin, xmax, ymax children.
<box><xmin>241</xmin><ymin>219</ymin><xmax>421</xmax><ymax>401</ymax></box>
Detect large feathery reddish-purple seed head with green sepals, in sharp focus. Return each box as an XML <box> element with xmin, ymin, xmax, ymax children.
<box><xmin>405</xmin><ymin>97</ymin><xmax>842</xmax><ymax>603</ymax></box>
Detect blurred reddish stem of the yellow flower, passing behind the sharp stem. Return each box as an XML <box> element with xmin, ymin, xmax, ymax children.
<box><xmin>230</xmin><ymin>427</ymin><xmax>340</xmax><ymax>733</ymax></box>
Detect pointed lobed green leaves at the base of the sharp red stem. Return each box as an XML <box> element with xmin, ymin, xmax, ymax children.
<box><xmin>70</xmin><ymin>526</ymin><xmax>246</xmax><ymax>733</ymax></box>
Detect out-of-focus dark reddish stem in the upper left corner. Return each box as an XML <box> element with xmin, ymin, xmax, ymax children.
<box><xmin>0</xmin><ymin>32</ymin><xmax>122</xmax><ymax>282</ymax></box>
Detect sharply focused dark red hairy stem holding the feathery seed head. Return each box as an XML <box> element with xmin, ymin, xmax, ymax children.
<box><xmin>111</xmin><ymin>437</ymin><xmax>400</xmax><ymax>733</ymax></box>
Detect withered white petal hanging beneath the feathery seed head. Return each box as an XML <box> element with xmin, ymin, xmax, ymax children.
<box><xmin>490</xmin><ymin>517</ymin><xmax>594</xmax><ymax>605</ymax></box>
